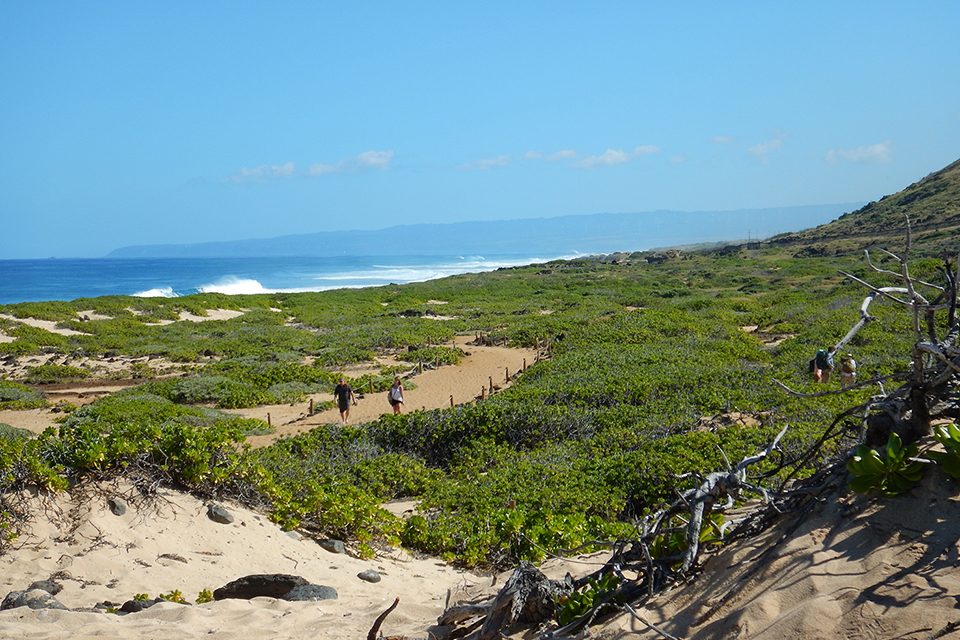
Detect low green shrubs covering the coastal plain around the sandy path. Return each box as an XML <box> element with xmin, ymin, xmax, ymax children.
<box><xmin>0</xmin><ymin>181</ymin><xmax>946</xmax><ymax>568</ymax></box>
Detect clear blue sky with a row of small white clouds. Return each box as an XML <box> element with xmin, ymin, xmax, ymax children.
<box><xmin>0</xmin><ymin>0</ymin><xmax>960</xmax><ymax>259</ymax></box>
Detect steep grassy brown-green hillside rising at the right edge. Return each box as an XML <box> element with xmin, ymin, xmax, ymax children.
<box><xmin>771</xmin><ymin>160</ymin><xmax>960</xmax><ymax>256</ymax></box>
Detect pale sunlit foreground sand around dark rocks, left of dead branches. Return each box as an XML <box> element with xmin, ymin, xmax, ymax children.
<box><xmin>0</xmin><ymin>487</ymin><xmax>491</xmax><ymax>640</ymax></box>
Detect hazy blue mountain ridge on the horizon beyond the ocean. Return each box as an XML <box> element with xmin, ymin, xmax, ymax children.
<box><xmin>106</xmin><ymin>203</ymin><xmax>862</xmax><ymax>258</ymax></box>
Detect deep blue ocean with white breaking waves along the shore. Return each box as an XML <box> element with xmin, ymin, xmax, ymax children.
<box><xmin>0</xmin><ymin>255</ymin><xmax>574</xmax><ymax>304</ymax></box>
